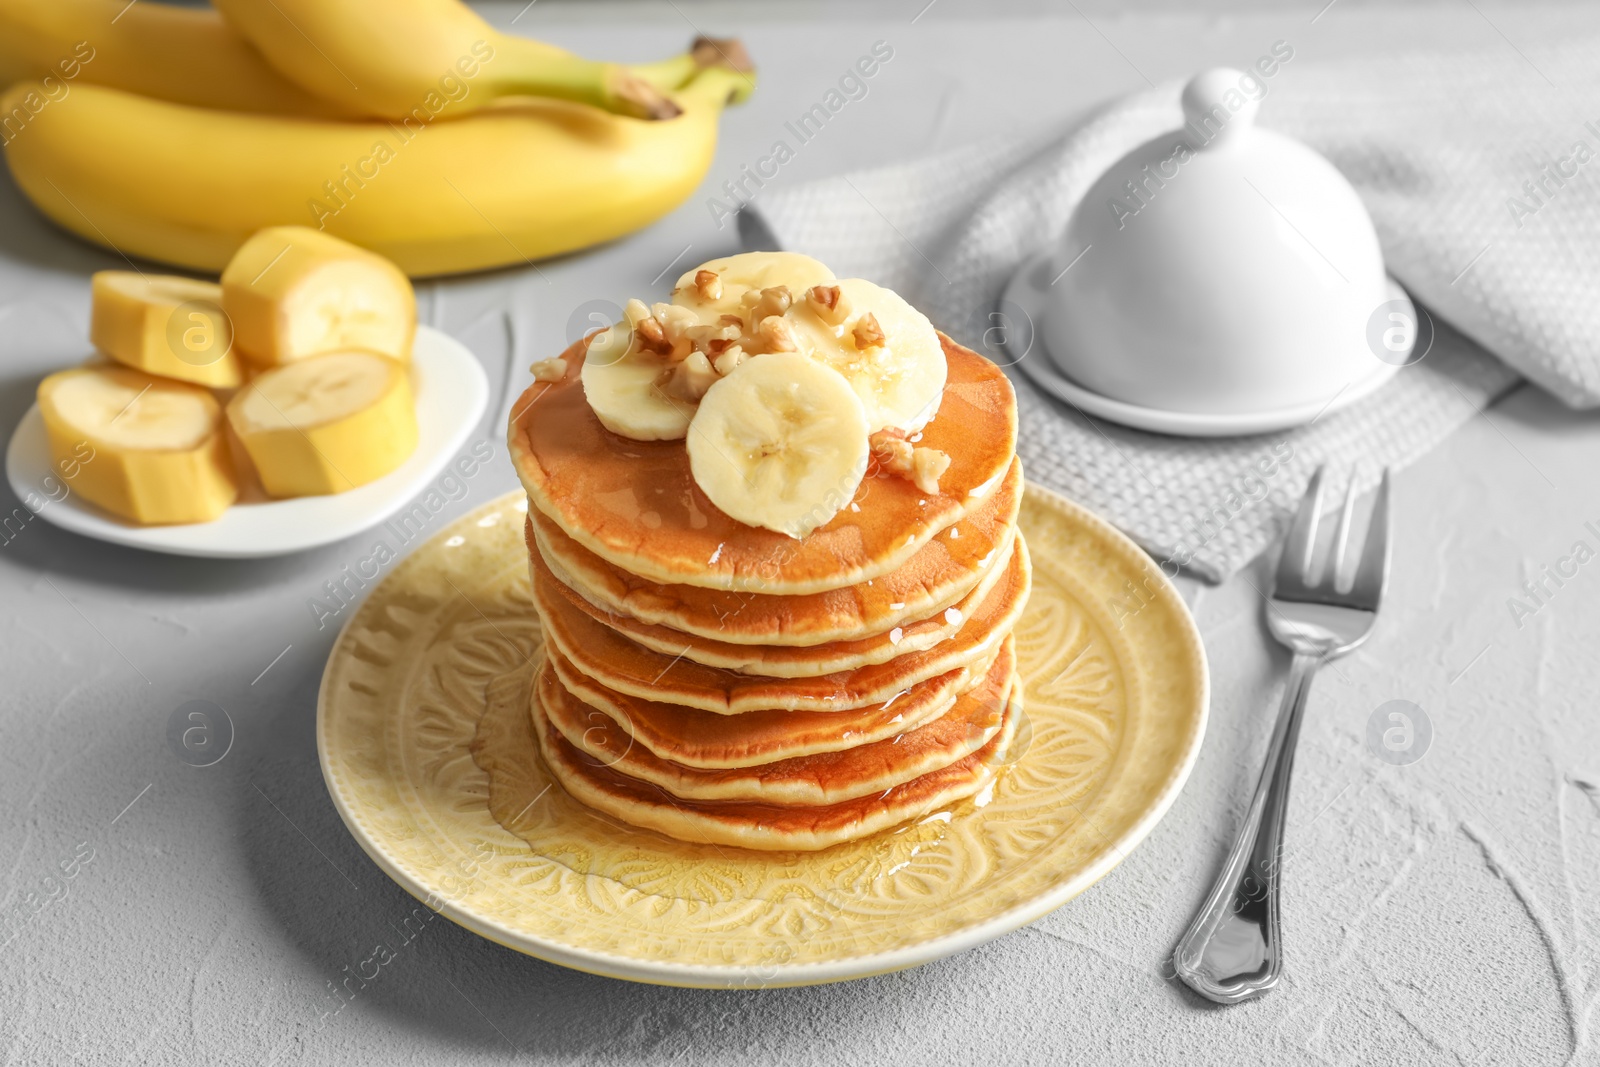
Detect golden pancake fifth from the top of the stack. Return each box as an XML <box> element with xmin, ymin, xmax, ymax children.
<box><xmin>544</xmin><ymin>646</ymin><xmax>995</xmax><ymax>771</ymax></box>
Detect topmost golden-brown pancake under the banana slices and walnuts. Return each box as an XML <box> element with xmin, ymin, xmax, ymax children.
<box><xmin>507</xmin><ymin>334</ymin><xmax>1016</xmax><ymax>595</ymax></box>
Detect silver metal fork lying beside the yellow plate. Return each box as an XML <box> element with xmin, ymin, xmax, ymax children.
<box><xmin>1173</xmin><ymin>467</ymin><xmax>1389</xmax><ymax>1005</ymax></box>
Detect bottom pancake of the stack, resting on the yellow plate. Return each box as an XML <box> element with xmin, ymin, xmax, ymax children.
<box><xmin>533</xmin><ymin>685</ymin><xmax>1022</xmax><ymax>851</ymax></box>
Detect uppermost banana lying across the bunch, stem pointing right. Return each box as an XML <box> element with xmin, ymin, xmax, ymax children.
<box><xmin>216</xmin><ymin>0</ymin><xmax>677</xmax><ymax>118</ymax></box>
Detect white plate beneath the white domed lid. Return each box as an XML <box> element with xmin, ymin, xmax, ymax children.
<box><xmin>1000</xmin><ymin>251</ymin><xmax>1416</xmax><ymax>437</ymax></box>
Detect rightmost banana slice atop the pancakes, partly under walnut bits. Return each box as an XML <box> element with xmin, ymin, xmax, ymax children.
<box><xmin>789</xmin><ymin>278</ymin><xmax>946</xmax><ymax>434</ymax></box>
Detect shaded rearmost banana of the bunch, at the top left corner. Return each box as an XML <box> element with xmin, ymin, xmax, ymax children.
<box><xmin>0</xmin><ymin>0</ymin><xmax>360</xmax><ymax>117</ymax></box>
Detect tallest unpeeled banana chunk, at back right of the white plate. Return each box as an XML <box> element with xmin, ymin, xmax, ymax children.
<box><xmin>222</xmin><ymin>226</ymin><xmax>416</xmax><ymax>365</ymax></box>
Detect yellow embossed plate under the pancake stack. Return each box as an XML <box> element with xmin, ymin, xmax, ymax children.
<box><xmin>317</xmin><ymin>486</ymin><xmax>1206</xmax><ymax>987</ymax></box>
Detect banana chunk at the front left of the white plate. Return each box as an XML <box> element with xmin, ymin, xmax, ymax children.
<box><xmin>38</xmin><ymin>366</ymin><xmax>238</xmax><ymax>525</ymax></box>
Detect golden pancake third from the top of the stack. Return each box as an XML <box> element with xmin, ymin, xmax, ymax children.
<box><xmin>531</xmin><ymin>537</ymin><xmax>1011</xmax><ymax>678</ymax></box>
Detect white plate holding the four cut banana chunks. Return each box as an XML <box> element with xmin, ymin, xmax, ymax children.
<box><xmin>5</xmin><ymin>323</ymin><xmax>490</xmax><ymax>560</ymax></box>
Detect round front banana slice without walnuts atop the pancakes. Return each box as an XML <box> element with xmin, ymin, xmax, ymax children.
<box><xmin>688</xmin><ymin>352</ymin><xmax>869</xmax><ymax>539</ymax></box>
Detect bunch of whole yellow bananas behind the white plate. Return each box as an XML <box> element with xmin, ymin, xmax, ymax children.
<box><xmin>0</xmin><ymin>0</ymin><xmax>754</xmax><ymax>277</ymax></box>
